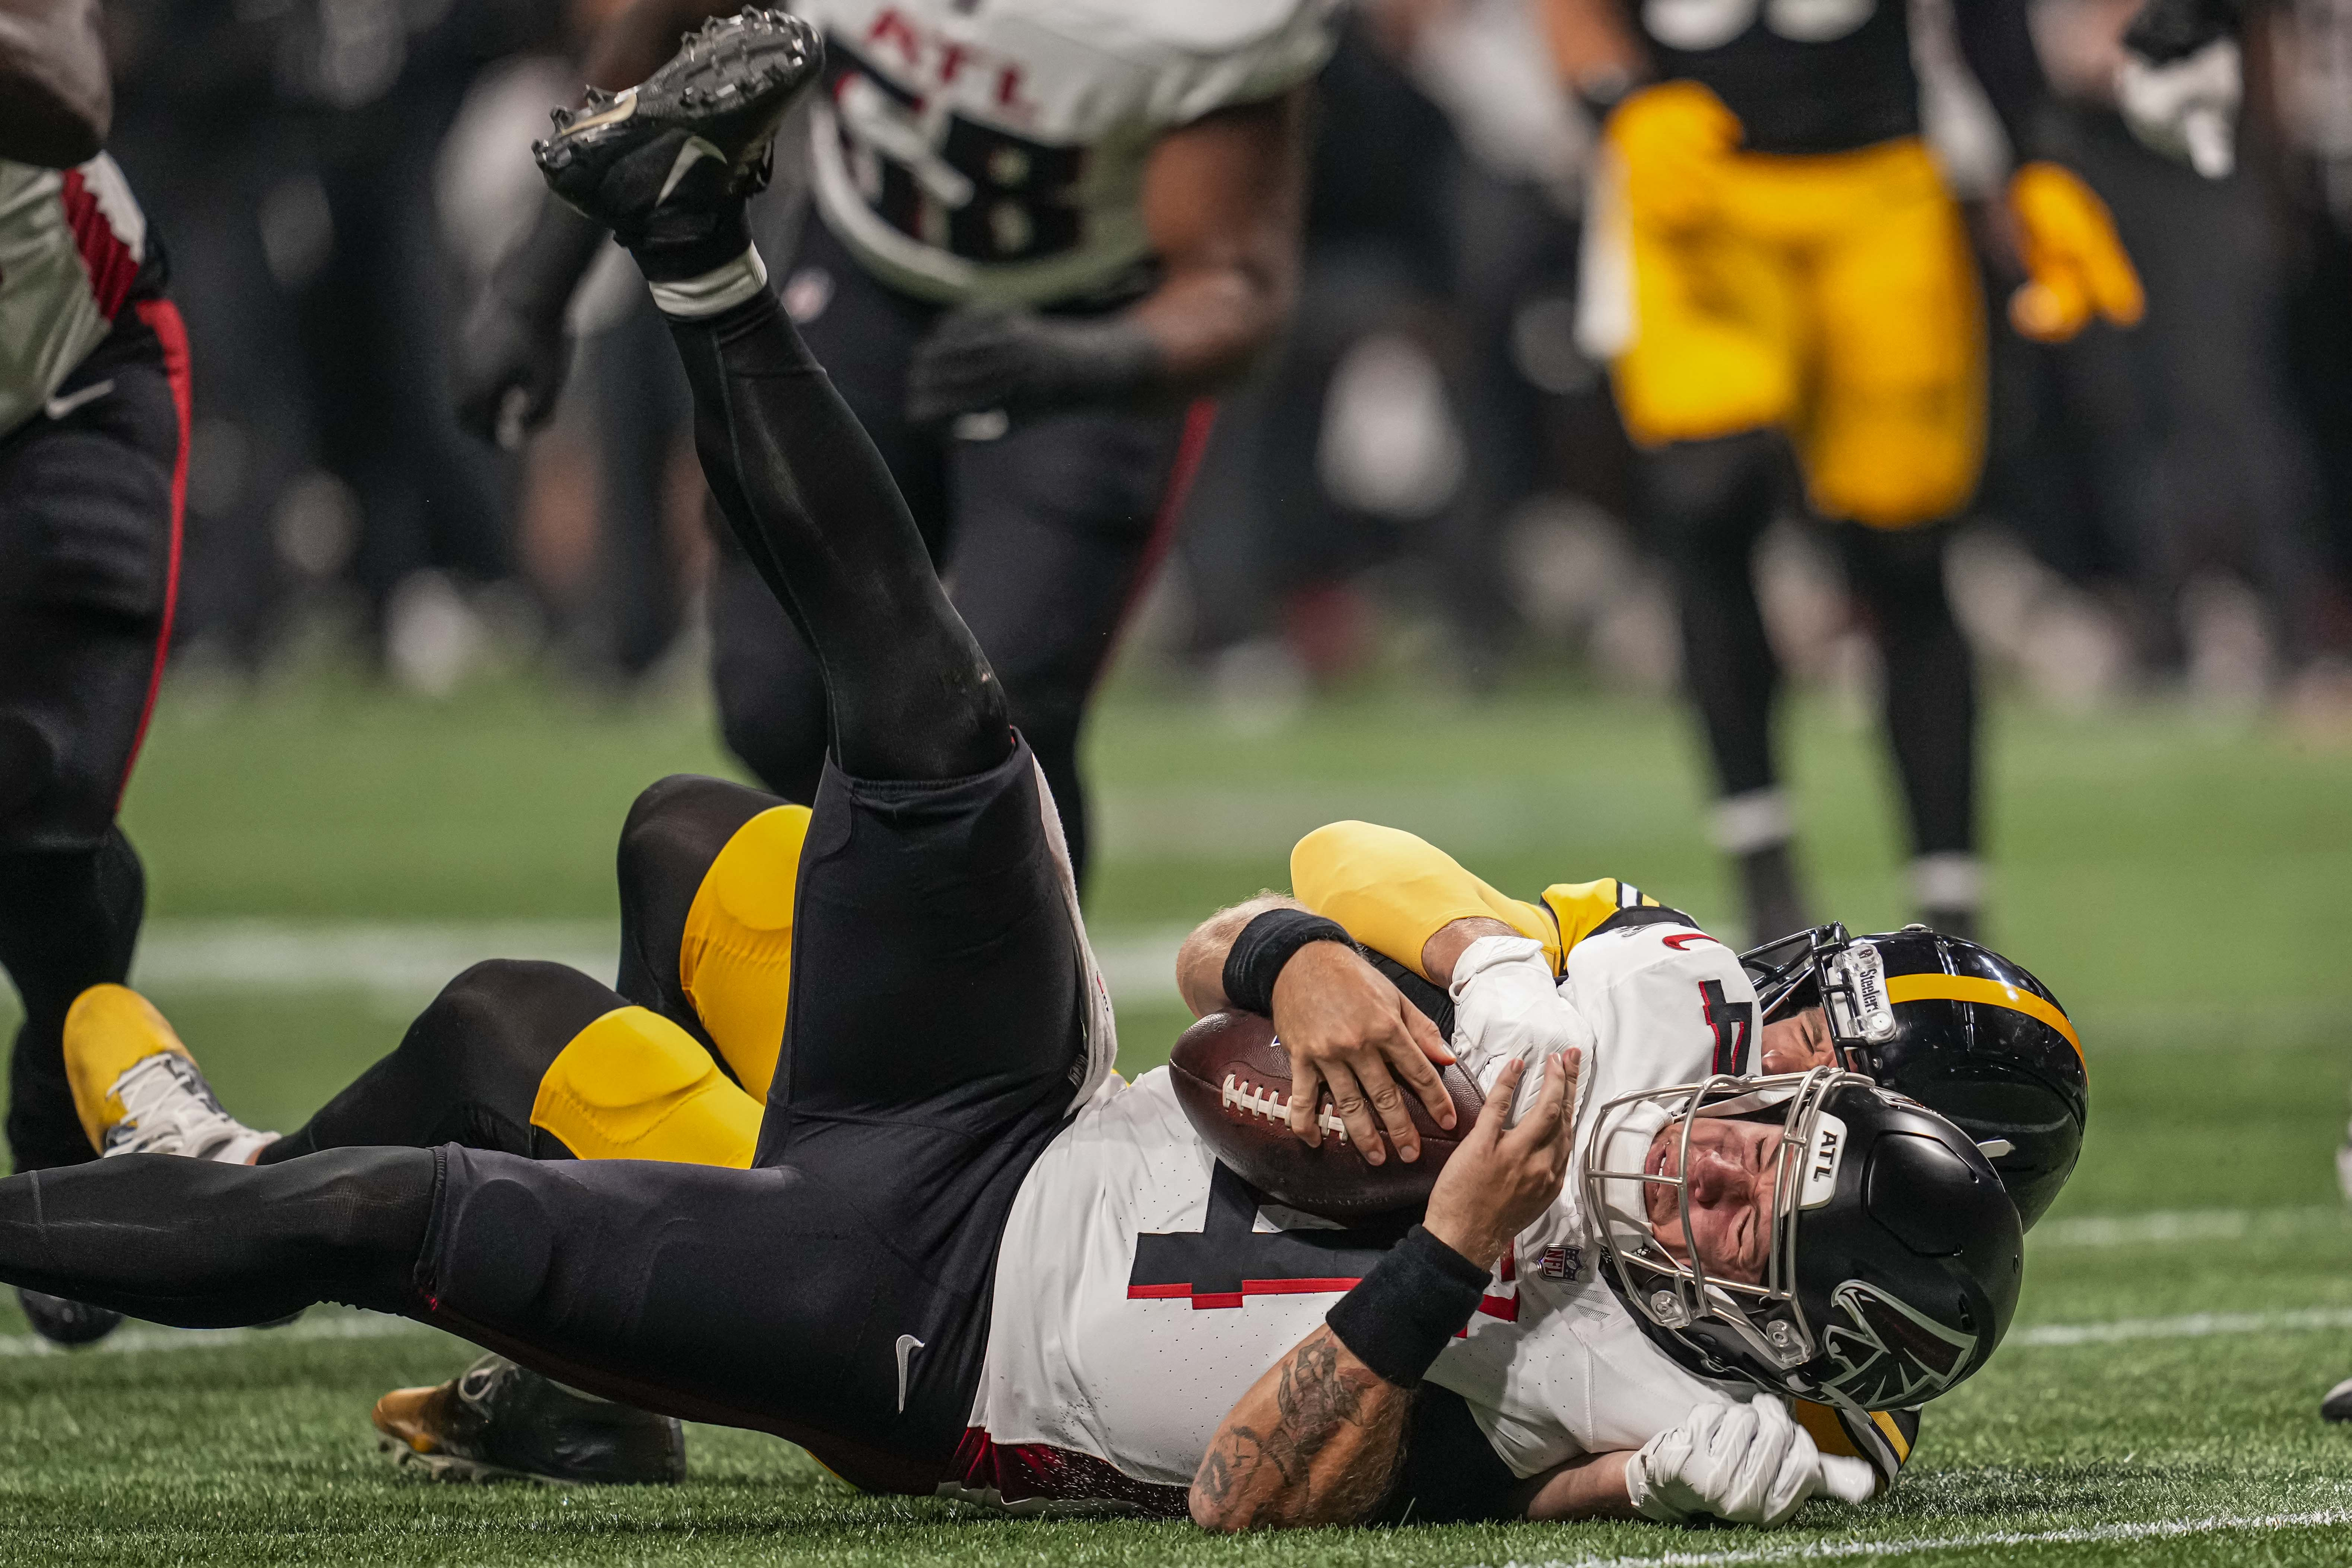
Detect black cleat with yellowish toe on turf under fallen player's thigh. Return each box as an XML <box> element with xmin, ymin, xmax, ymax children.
<box><xmin>374</xmin><ymin>1356</ymin><xmax>687</xmax><ymax>1486</ymax></box>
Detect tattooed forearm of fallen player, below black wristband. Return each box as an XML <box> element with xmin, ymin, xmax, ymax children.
<box><xmin>1193</xmin><ymin>1328</ymin><xmax>1413</xmax><ymax>1530</ymax></box>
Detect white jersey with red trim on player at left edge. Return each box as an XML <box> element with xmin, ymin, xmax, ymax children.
<box><xmin>0</xmin><ymin>153</ymin><xmax>146</xmax><ymax>432</ymax></box>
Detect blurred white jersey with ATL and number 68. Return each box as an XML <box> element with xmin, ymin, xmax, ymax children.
<box><xmin>793</xmin><ymin>0</ymin><xmax>1338</xmax><ymax>306</ymax></box>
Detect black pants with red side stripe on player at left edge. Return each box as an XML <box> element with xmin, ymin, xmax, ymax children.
<box><xmin>0</xmin><ymin>299</ymin><xmax>188</xmax><ymax>1171</ymax></box>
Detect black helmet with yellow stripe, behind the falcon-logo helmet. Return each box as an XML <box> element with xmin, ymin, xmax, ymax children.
<box><xmin>1740</xmin><ymin>924</ymin><xmax>2091</xmax><ymax>1227</ymax></box>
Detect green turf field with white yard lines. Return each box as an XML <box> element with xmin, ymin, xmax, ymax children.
<box><xmin>0</xmin><ymin>677</ymin><xmax>2352</xmax><ymax>1568</ymax></box>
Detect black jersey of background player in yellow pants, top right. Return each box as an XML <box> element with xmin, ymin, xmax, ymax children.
<box><xmin>1628</xmin><ymin>0</ymin><xmax>1919</xmax><ymax>153</ymax></box>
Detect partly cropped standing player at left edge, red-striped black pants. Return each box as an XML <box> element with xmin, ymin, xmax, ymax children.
<box><xmin>0</xmin><ymin>0</ymin><xmax>188</xmax><ymax>1345</ymax></box>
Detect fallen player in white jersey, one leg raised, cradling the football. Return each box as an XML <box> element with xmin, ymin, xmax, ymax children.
<box><xmin>0</xmin><ymin>12</ymin><xmax>2023</xmax><ymax>1528</ymax></box>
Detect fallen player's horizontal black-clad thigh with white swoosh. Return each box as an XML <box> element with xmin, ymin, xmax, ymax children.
<box><xmin>419</xmin><ymin>1147</ymin><xmax>983</xmax><ymax>1493</ymax></box>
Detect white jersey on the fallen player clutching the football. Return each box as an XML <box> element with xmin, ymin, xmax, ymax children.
<box><xmin>948</xmin><ymin>924</ymin><xmax>1755</xmax><ymax>1509</ymax></box>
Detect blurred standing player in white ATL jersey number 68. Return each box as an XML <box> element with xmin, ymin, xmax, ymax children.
<box><xmin>458</xmin><ymin>0</ymin><xmax>1336</xmax><ymax>884</ymax></box>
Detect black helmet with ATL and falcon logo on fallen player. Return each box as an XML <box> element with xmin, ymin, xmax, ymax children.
<box><xmin>1583</xmin><ymin>1067</ymin><xmax>2025</xmax><ymax>1410</ymax></box>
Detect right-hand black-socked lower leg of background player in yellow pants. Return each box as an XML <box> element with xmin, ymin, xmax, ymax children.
<box><xmin>1837</xmin><ymin>524</ymin><xmax>1983</xmax><ymax>938</ymax></box>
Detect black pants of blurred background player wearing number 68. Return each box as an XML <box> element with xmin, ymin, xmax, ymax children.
<box><xmin>710</xmin><ymin>219</ymin><xmax>1209</xmax><ymax>875</ymax></box>
